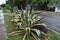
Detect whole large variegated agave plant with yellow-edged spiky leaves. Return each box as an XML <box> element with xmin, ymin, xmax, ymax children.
<box><xmin>10</xmin><ymin>7</ymin><xmax>48</xmax><ymax>40</ymax></box>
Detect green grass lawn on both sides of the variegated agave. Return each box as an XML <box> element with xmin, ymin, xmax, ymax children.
<box><xmin>4</xmin><ymin>15</ymin><xmax>60</xmax><ymax>40</ymax></box>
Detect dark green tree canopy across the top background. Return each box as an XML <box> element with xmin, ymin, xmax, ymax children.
<box><xmin>7</xmin><ymin>0</ymin><xmax>60</xmax><ymax>11</ymax></box>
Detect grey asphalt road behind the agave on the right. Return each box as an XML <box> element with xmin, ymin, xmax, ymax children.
<box><xmin>38</xmin><ymin>14</ymin><xmax>60</xmax><ymax>33</ymax></box>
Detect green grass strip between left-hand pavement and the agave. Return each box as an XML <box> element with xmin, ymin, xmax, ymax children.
<box><xmin>4</xmin><ymin>15</ymin><xmax>21</xmax><ymax>40</ymax></box>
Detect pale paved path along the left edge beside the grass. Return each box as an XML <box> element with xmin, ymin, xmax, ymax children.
<box><xmin>0</xmin><ymin>10</ymin><xmax>7</xmax><ymax>40</ymax></box>
